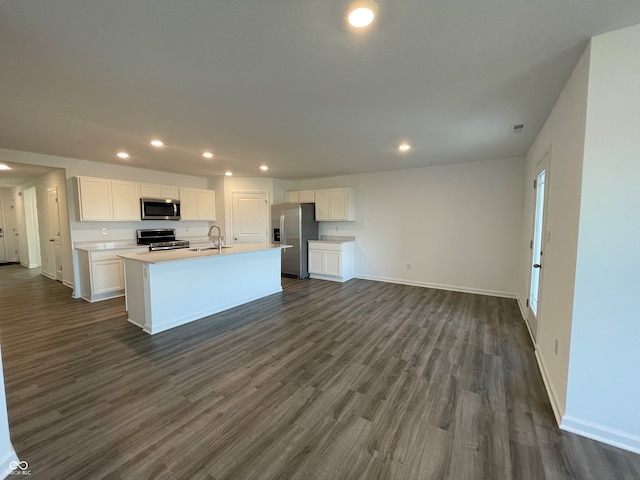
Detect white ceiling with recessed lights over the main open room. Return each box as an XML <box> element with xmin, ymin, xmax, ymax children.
<box><xmin>0</xmin><ymin>0</ymin><xmax>640</xmax><ymax>179</ymax></box>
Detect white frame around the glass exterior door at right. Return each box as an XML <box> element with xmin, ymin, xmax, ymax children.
<box><xmin>527</xmin><ymin>145</ymin><xmax>551</xmax><ymax>341</ymax></box>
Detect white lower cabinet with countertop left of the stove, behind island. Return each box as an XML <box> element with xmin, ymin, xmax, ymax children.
<box><xmin>76</xmin><ymin>247</ymin><xmax>148</xmax><ymax>302</ymax></box>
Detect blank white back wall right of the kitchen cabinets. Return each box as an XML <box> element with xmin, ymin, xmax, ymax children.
<box><xmin>290</xmin><ymin>158</ymin><xmax>524</xmax><ymax>297</ymax></box>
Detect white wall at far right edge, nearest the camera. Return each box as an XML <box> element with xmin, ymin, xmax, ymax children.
<box><xmin>563</xmin><ymin>25</ymin><xmax>640</xmax><ymax>453</ymax></box>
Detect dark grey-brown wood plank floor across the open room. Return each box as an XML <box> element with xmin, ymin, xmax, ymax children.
<box><xmin>0</xmin><ymin>266</ymin><xmax>640</xmax><ymax>480</ymax></box>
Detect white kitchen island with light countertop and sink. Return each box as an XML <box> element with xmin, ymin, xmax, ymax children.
<box><xmin>119</xmin><ymin>244</ymin><xmax>287</xmax><ymax>335</ymax></box>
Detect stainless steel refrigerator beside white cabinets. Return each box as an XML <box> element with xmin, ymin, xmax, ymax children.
<box><xmin>271</xmin><ymin>203</ymin><xmax>318</xmax><ymax>278</ymax></box>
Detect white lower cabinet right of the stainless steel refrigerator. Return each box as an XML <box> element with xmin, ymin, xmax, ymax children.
<box><xmin>309</xmin><ymin>240</ymin><xmax>355</xmax><ymax>282</ymax></box>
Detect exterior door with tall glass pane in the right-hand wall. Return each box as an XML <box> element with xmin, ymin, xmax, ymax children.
<box><xmin>528</xmin><ymin>152</ymin><xmax>550</xmax><ymax>338</ymax></box>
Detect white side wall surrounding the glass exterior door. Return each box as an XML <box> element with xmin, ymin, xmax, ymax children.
<box><xmin>518</xmin><ymin>47</ymin><xmax>589</xmax><ymax>423</ymax></box>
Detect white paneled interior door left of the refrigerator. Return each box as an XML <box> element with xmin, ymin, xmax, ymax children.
<box><xmin>231</xmin><ymin>192</ymin><xmax>269</xmax><ymax>243</ymax></box>
